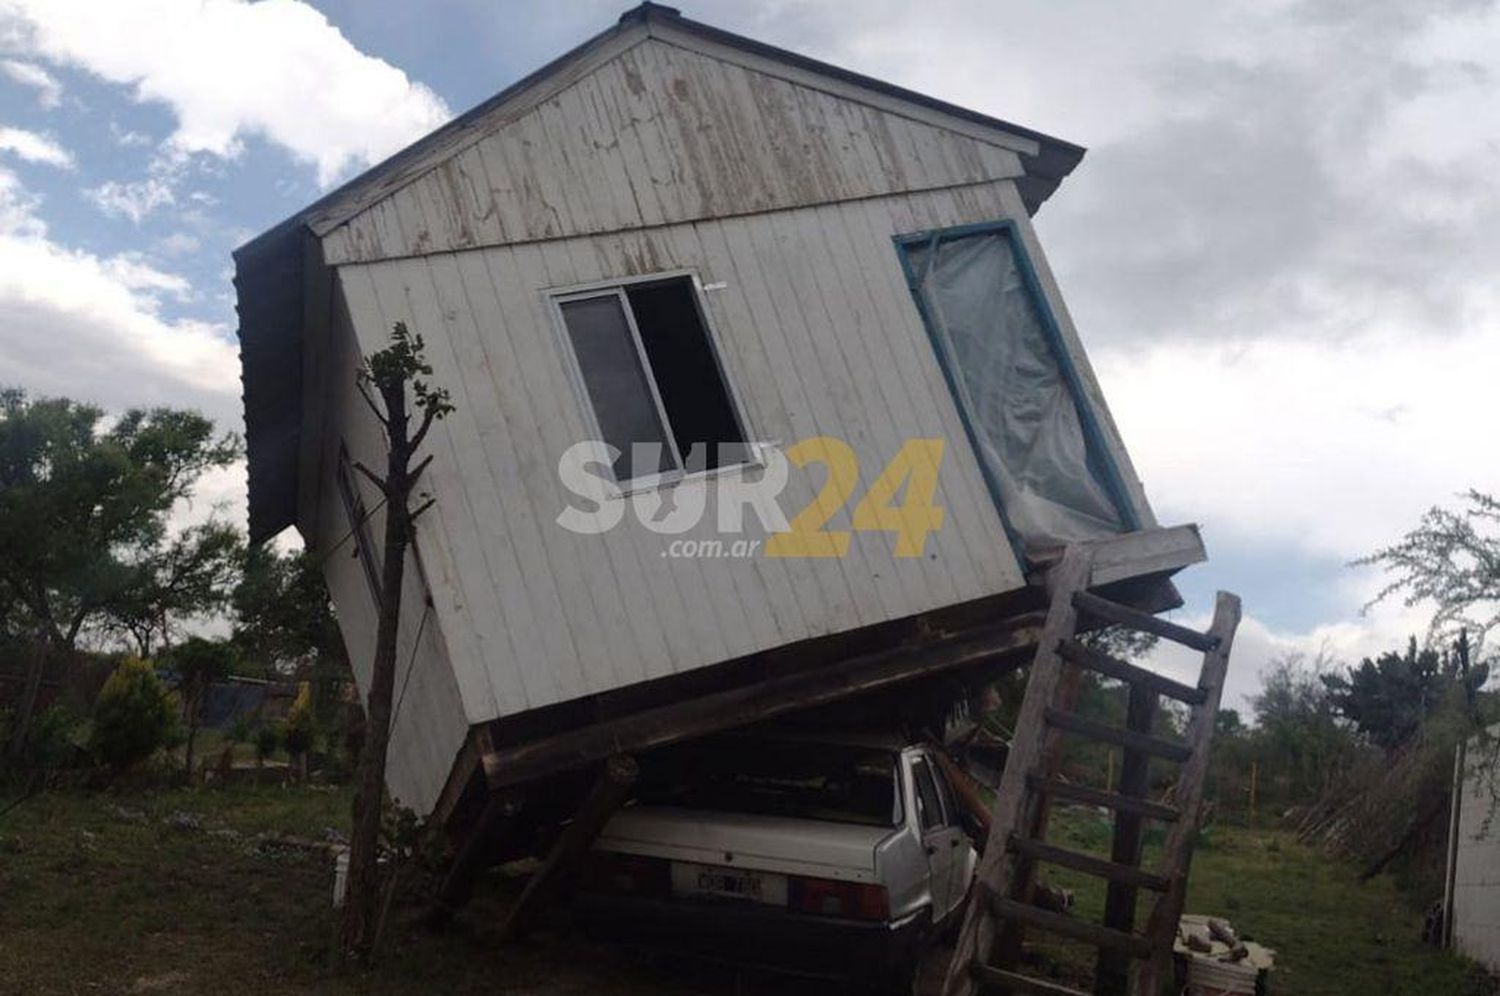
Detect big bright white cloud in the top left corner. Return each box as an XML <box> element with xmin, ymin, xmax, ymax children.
<box><xmin>0</xmin><ymin>0</ymin><xmax>450</xmax><ymax>186</ymax></box>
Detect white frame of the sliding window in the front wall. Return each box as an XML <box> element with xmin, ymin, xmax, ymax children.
<box><xmin>543</xmin><ymin>270</ymin><xmax>765</xmax><ymax>497</ymax></box>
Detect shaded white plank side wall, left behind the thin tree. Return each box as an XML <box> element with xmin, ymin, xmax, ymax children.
<box><xmin>308</xmin><ymin>292</ymin><xmax>465</xmax><ymax>813</ymax></box>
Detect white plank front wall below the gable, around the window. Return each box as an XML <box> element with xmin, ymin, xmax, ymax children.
<box><xmin>338</xmin><ymin>182</ymin><xmax>1092</xmax><ymax>723</ymax></box>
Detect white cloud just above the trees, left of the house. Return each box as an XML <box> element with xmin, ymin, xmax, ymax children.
<box><xmin>0</xmin><ymin>171</ymin><xmax>240</xmax><ymax>429</ymax></box>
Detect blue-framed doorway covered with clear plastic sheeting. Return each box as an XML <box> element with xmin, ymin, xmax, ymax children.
<box><xmin>896</xmin><ymin>221</ymin><xmax>1140</xmax><ymax>561</ymax></box>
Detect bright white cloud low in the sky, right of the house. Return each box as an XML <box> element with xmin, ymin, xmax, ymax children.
<box><xmin>1094</xmin><ymin>321</ymin><xmax>1500</xmax><ymax>561</ymax></box>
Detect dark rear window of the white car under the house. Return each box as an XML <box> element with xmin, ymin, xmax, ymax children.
<box><xmin>636</xmin><ymin>741</ymin><xmax>902</xmax><ymax>827</ymax></box>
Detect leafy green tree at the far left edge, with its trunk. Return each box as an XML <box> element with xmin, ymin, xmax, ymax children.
<box><xmin>0</xmin><ymin>389</ymin><xmax>240</xmax><ymax>756</ymax></box>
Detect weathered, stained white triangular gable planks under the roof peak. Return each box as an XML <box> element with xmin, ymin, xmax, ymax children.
<box><xmin>324</xmin><ymin>38</ymin><xmax>1022</xmax><ymax>264</ymax></box>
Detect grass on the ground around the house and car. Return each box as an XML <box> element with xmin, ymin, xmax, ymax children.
<box><xmin>0</xmin><ymin>786</ymin><xmax>1490</xmax><ymax>996</ymax></box>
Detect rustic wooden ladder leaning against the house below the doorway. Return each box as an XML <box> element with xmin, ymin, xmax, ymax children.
<box><xmin>942</xmin><ymin>545</ymin><xmax>1239</xmax><ymax>996</ymax></box>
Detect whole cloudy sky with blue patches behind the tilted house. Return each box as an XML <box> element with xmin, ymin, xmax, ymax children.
<box><xmin>0</xmin><ymin>0</ymin><xmax>1500</xmax><ymax>699</ymax></box>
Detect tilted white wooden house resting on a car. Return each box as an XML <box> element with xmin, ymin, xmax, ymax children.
<box><xmin>236</xmin><ymin>5</ymin><xmax>1202</xmax><ymax>818</ymax></box>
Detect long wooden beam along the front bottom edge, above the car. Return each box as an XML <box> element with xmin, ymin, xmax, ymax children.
<box><xmin>483</xmin><ymin>614</ymin><xmax>1040</xmax><ymax>789</ymax></box>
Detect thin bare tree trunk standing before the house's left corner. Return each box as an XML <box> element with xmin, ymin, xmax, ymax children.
<box><xmin>339</xmin><ymin>384</ymin><xmax>411</xmax><ymax>962</ymax></box>
